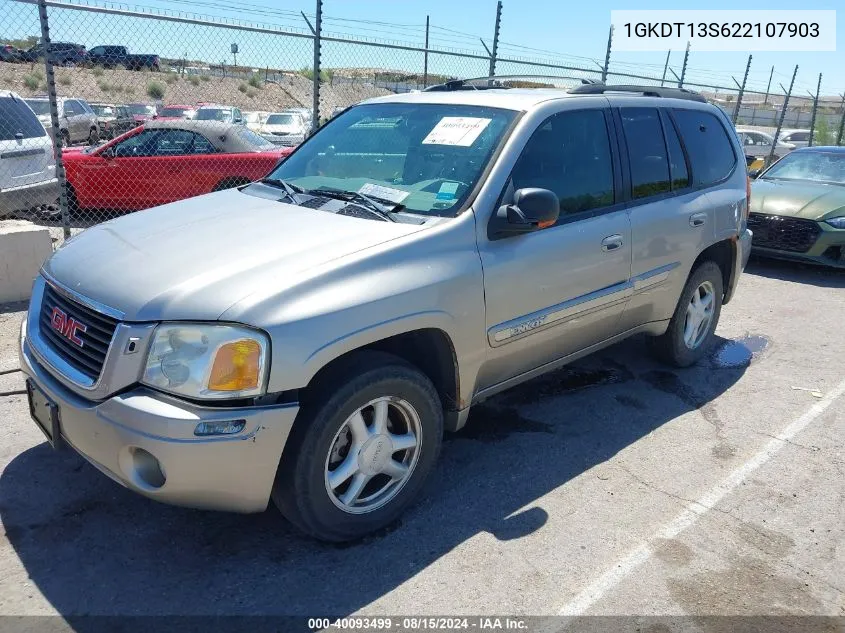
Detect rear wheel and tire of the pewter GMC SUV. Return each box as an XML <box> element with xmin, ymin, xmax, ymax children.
<box><xmin>648</xmin><ymin>261</ymin><xmax>724</xmax><ymax>367</ymax></box>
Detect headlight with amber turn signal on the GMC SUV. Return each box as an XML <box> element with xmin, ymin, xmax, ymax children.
<box><xmin>141</xmin><ymin>323</ymin><xmax>270</xmax><ymax>399</ymax></box>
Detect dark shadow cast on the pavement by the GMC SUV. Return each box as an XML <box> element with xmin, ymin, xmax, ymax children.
<box><xmin>0</xmin><ymin>338</ymin><xmax>750</xmax><ymax>620</ymax></box>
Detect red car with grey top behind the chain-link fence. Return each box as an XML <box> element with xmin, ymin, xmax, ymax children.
<box><xmin>63</xmin><ymin>120</ymin><xmax>293</xmax><ymax>211</ymax></box>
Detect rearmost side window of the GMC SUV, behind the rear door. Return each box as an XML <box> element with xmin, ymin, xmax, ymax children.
<box><xmin>674</xmin><ymin>110</ymin><xmax>736</xmax><ymax>187</ymax></box>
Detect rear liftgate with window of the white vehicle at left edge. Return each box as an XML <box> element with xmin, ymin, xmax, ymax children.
<box><xmin>0</xmin><ymin>96</ymin><xmax>55</xmax><ymax>195</ymax></box>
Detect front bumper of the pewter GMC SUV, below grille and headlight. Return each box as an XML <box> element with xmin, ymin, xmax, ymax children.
<box><xmin>19</xmin><ymin>321</ymin><xmax>299</xmax><ymax>512</ymax></box>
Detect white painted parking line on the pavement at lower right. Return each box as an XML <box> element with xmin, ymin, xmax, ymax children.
<box><xmin>558</xmin><ymin>380</ymin><xmax>845</xmax><ymax>616</ymax></box>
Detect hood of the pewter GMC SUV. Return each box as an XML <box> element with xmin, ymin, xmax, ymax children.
<box><xmin>44</xmin><ymin>189</ymin><xmax>422</xmax><ymax>321</ymax></box>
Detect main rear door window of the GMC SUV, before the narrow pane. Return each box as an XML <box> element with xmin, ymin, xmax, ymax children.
<box><xmin>620</xmin><ymin>108</ymin><xmax>672</xmax><ymax>200</ymax></box>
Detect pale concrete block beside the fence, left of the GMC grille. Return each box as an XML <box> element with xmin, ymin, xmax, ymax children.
<box><xmin>0</xmin><ymin>220</ymin><xmax>53</xmax><ymax>303</ymax></box>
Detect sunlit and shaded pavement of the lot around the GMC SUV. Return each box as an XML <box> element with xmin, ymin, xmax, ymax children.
<box><xmin>0</xmin><ymin>261</ymin><xmax>845</xmax><ymax>631</ymax></box>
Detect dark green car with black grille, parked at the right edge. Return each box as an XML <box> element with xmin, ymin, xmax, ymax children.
<box><xmin>748</xmin><ymin>146</ymin><xmax>845</xmax><ymax>268</ymax></box>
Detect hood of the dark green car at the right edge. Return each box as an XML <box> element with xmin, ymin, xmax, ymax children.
<box><xmin>750</xmin><ymin>180</ymin><xmax>845</xmax><ymax>220</ymax></box>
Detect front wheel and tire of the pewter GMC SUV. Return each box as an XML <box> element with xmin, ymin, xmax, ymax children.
<box><xmin>272</xmin><ymin>351</ymin><xmax>443</xmax><ymax>542</ymax></box>
